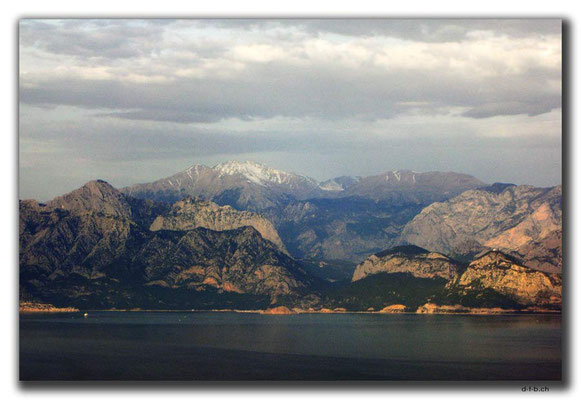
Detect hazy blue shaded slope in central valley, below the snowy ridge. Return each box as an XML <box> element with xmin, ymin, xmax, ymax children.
<box><xmin>263</xmin><ymin>197</ymin><xmax>424</xmax><ymax>263</ymax></box>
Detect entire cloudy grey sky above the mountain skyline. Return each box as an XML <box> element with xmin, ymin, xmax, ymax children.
<box><xmin>19</xmin><ymin>19</ymin><xmax>562</xmax><ymax>201</ymax></box>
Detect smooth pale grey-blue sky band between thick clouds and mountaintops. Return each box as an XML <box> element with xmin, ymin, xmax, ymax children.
<box><xmin>20</xmin><ymin>106</ymin><xmax>561</xmax><ymax>200</ymax></box>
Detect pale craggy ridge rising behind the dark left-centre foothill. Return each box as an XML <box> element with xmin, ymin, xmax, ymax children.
<box><xmin>149</xmin><ymin>197</ymin><xmax>286</xmax><ymax>253</ymax></box>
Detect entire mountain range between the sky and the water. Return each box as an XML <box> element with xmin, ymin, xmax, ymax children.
<box><xmin>19</xmin><ymin>162</ymin><xmax>562</xmax><ymax>312</ymax></box>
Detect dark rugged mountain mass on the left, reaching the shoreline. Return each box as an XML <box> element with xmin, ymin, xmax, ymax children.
<box><xmin>19</xmin><ymin>181</ymin><xmax>313</xmax><ymax>309</ymax></box>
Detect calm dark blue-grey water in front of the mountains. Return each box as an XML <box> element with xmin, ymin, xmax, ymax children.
<box><xmin>20</xmin><ymin>312</ymin><xmax>561</xmax><ymax>380</ymax></box>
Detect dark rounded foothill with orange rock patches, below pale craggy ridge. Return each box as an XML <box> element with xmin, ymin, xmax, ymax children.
<box><xmin>132</xmin><ymin>227</ymin><xmax>308</xmax><ymax>298</ymax></box>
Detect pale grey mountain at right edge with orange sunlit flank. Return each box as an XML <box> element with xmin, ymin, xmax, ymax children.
<box><xmin>399</xmin><ymin>185</ymin><xmax>562</xmax><ymax>272</ymax></box>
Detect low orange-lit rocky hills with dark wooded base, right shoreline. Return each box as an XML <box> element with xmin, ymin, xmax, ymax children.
<box><xmin>322</xmin><ymin>246</ymin><xmax>562</xmax><ymax>313</ymax></box>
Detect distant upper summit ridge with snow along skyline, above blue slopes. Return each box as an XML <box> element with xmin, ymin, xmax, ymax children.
<box><xmin>121</xmin><ymin>161</ymin><xmax>484</xmax><ymax>211</ymax></box>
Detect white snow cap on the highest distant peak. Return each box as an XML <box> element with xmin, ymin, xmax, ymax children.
<box><xmin>212</xmin><ymin>161</ymin><xmax>311</xmax><ymax>186</ymax></box>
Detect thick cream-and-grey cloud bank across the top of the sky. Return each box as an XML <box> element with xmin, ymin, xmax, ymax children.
<box><xmin>20</xmin><ymin>20</ymin><xmax>561</xmax><ymax>123</ymax></box>
